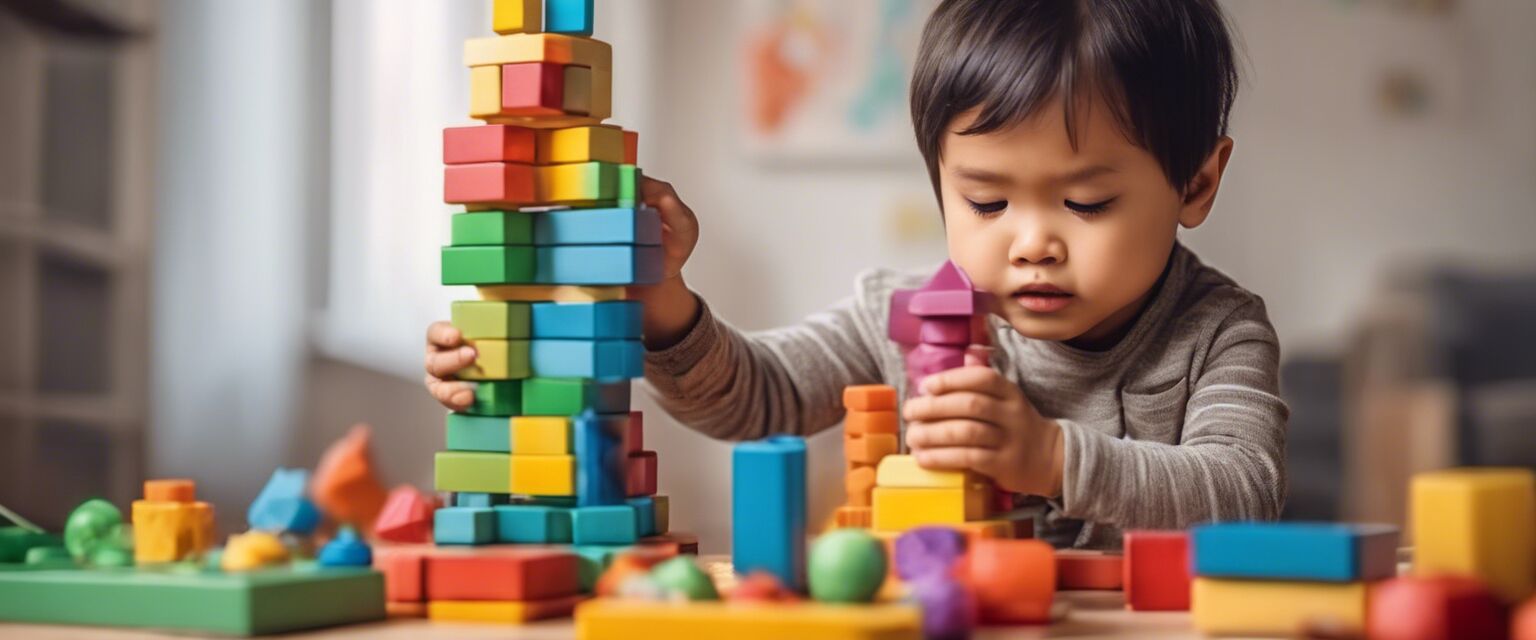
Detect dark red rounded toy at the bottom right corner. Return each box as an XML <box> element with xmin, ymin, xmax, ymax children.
<box><xmin>1366</xmin><ymin>576</ymin><xmax>1508</xmax><ymax>640</ymax></box>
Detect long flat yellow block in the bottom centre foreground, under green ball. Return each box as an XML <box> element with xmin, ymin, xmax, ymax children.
<box><xmin>576</xmin><ymin>599</ymin><xmax>923</xmax><ymax>640</ymax></box>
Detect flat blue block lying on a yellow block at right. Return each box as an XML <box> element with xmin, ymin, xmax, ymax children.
<box><xmin>1190</xmin><ymin>522</ymin><xmax>1398</xmax><ymax>582</ymax></box>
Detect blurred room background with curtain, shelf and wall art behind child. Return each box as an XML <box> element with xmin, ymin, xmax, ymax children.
<box><xmin>0</xmin><ymin>0</ymin><xmax>1536</xmax><ymax>551</ymax></box>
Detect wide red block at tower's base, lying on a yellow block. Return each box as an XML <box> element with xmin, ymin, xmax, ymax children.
<box><xmin>425</xmin><ymin>549</ymin><xmax>579</xmax><ymax>602</ymax></box>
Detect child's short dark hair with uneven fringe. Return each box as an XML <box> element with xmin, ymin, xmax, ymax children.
<box><xmin>911</xmin><ymin>0</ymin><xmax>1238</xmax><ymax>206</ymax></box>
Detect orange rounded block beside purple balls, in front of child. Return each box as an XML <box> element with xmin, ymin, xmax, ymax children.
<box><xmin>966</xmin><ymin>540</ymin><xmax>1057</xmax><ymax>625</ymax></box>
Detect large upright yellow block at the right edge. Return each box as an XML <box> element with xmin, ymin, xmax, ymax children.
<box><xmin>1409</xmin><ymin>467</ymin><xmax>1536</xmax><ymax>602</ymax></box>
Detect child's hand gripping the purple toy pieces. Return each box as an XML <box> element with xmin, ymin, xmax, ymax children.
<box><xmin>902</xmin><ymin>367</ymin><xmax>1063</xmax><ymax>497</ymax></box>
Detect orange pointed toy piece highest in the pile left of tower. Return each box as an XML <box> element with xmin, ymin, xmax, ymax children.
<box><xmin>309</xmin><ymin>424</ymin><xmax>387</xmax><ymax>531</ymax></box>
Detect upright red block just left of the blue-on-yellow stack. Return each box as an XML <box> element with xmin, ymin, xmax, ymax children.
<box><xmin>1124</xmin><ymin>531</ymin><xmax>1189</xmax><ymax>611</ymax></box>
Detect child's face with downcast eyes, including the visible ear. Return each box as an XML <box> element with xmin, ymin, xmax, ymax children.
<box><xmin>940</xmin><ymin>100</ymin><xmax>1230</xmax><ymax>348</ymax></box>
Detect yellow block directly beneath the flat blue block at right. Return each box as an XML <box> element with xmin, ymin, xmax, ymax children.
<box><xmin>1190</xmin><ymin>577</ymin><xmax>1367</xmax><ymax>637</ymax></box>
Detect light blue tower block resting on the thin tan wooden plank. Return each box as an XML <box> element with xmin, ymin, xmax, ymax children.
<box><xmin>534</xmin><ymin>244</ymin><xmax>662</xmax><ymax>284</ymax></box>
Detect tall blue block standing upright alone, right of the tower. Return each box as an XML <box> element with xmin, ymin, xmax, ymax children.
<box><xmin>731</xmin><ymin>436</ymin><xmax>806</xmax><ymax>591</ymax></box>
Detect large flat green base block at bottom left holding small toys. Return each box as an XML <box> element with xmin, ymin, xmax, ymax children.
<box><xmin>0</xmin><ymin>565</ymin><xmax>384</xmax><ymax>635</ymax></box>
